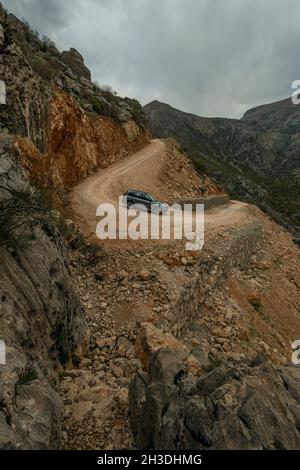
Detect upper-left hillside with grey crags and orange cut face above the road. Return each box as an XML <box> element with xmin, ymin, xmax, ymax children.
<box><xmin>0</xmin><ymin>2</ymin><xmax>149</xmax><ymax>186</ymax></box>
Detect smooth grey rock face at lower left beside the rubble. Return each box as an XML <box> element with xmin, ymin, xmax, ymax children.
<box><xmin>0</xmin><ymin>142</ymin><xmax>87</xmax><ymax>449</ymax></box>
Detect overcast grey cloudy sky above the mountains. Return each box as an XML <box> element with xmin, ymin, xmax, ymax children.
<box><xmin>2</xmin><ymin>0</ymin><xmax>300</xmax><ymax>117</ymax></box>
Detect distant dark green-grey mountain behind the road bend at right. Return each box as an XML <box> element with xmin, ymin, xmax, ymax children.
<box><xmin>144</xmin><ymin>99</ymin><xmax>300</xmax><ymax>233</ymax></box>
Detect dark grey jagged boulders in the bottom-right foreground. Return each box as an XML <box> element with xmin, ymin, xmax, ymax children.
<box><xmin>129</xmin><ymin>349</ymin><xmax>300</xmax><ymax>450</ymax></box>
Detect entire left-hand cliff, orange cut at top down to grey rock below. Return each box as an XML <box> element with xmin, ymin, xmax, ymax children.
<box><xmin>0</xmin><ymin>4</ymin><xmax>149</xmax><ymax>449</ymax></box>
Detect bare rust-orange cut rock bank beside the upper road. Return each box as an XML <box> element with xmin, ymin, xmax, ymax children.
<box><xmin>16</xmin><ymin>88</ymin><xmax>148</xmax><ymax>187</ymax></box>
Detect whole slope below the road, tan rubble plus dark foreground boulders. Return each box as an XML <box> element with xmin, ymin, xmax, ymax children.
<box><xmin>61</xmin><ymin>197</ymin><xmax>300</xmax><ymax>449</ymax></box>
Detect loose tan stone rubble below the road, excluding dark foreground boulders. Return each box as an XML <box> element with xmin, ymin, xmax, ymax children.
<box><xmin>61</xmin><ymin>209</ymin><xmax>300</xmax><ymax>449</ymax></box>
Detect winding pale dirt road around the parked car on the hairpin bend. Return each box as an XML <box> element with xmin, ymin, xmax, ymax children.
<box><xmin>72</xmin><ymin>140</ymin><xmax>249</xmax><ymax>241</ymax></box>
